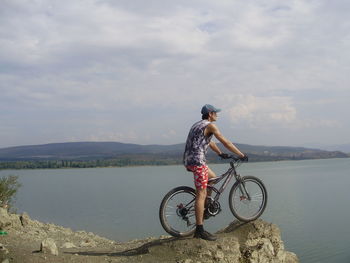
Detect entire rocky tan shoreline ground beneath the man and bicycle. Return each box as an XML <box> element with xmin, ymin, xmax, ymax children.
<box><xmin>0</xmin><ymin>208</ymin><xmax>298</xmax><ymax>263</ymax></box>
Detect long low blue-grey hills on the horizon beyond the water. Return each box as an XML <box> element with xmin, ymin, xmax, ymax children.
<box><xmin>0</xmin><ymin>142</ymin><xmax>349</xmax><ymax>163</ymax></box>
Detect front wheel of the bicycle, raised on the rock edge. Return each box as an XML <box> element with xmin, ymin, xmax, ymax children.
<box><xmin>229</xmin><ymin>176</ymin><xmax>267</xmax><ymax>222</ymax></box>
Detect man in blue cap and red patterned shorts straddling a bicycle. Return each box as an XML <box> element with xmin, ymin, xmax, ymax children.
<box><xmin>183</xmin><ymin>104</ymin><xmax>246</xmax><ymax>241</ymax></box>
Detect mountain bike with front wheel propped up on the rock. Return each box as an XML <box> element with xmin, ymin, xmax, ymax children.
<box><xmin>159</xmin><ymin>155</ymin><xmax>267</xmax><ymax>237</ymax></box>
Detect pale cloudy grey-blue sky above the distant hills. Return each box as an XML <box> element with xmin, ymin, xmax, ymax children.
<box><xmin>0</xmin><ymin>0</ymin><xmax>350</xmax><ymax>148</ymax></box>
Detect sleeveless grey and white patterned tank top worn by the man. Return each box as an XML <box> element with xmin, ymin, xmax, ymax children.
<box><xmin>183</xmin><ymin>120</ymin><xmax>213</xmax><ymax>166</ymax></box>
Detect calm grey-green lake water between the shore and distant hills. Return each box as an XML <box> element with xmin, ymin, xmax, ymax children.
<box><xmin>0</xmin><ymin>159</ymin><xmax>350</xmax><ymax>263</ymax></box>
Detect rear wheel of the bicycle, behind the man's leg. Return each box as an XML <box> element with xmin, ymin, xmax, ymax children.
<box><xmin>159</xmin><ymin>186</ymin><xmax>196</xmax><ymax>237</ymax></box>
